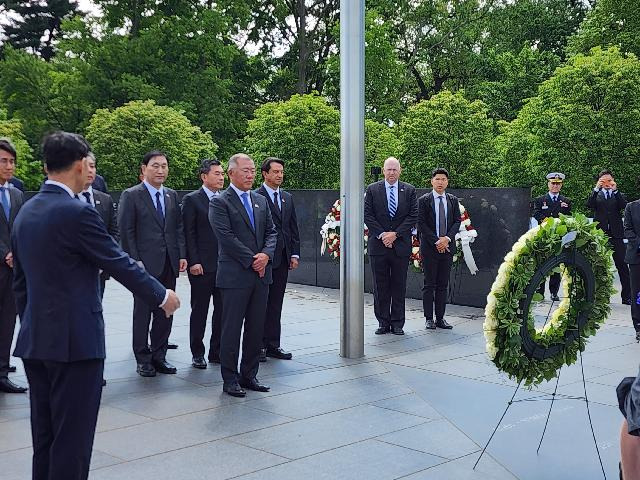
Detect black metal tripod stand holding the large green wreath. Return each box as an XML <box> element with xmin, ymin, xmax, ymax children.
<box><xmin>473</xmin><ymin>237</ymin><xmax>607</xmax><ymax>480</ymax></box>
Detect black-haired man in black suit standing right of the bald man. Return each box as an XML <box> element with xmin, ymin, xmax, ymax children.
<box><xmin>418</xmin><ymin>168</ymin><xmax>460</xmax><ymax>330</ymax></box>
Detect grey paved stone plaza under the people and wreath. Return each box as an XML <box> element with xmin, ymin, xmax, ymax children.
<box><xmin>0</xmin><ymin>277</ymin><xmax>640</xmax><ymax>480</ymax></box>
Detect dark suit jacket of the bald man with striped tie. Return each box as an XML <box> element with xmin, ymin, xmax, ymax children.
<box><xmin>364</xmin><ymin>180</ymin><xmax>418</xmax><ymax>257</ymax></box>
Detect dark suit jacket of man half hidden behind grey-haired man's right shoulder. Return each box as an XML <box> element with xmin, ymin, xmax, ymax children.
<box><xmin>182</xmin><ymin>188</ymin><xmax>218</xmax><ymax>273</ymax></box>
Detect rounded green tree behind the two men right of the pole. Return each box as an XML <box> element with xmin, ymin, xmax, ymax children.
<box><xmin>398</xmin><ymin>91</ymin><xmax>496</xmax><ymax>188</ymax></box>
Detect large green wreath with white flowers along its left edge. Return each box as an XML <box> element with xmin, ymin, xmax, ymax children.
<box><xmin>483</xmin><ymin>215</ymin><xmax>614</xmax><ymax>385</ymax></box>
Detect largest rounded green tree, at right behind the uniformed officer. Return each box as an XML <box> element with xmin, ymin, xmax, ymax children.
<box><xmin>496</xmin><ymin>48</ymin><xmax>640</xmax><ymax>209</ymax></box>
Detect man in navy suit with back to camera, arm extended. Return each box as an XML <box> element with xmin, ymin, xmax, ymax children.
<box><xmin>11</xmin><ymin>132</ymin><xmax>180</xmax><ymax>480</ymax></box>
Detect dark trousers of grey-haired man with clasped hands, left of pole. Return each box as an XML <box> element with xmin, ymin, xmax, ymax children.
<box><xmin>220</xmin><ymin>276</ymin><xmax>269</xmax><ymax>383</ymax></box>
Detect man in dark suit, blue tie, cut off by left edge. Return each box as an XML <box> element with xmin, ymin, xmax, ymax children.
<box><xmin>0</xmin><ymin>138</ymin><xmax>27</xmax><ymax>393</ymax></box>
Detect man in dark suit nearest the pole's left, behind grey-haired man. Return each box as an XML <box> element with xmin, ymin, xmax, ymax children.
<box><xmin>257</xmin><ymin>157</ymin><xmax>300</xmax><ymax>361</ymax></box>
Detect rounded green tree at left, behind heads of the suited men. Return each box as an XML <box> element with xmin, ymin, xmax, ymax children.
<box><xmin>87</xmin><ymin>100</ymin><xmax>217</xmax><ymax>190</ymax></box>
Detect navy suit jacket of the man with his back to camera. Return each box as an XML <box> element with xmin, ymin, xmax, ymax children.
<box><xmin>11</xmin><ymin>185</ymin><xmax>166</xmax><ymax>362</ymax></box>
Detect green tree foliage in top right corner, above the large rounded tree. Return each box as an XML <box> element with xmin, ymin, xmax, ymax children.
<box><xmin>568</xmin><ymin>0</ymin><xmax>640</xmax><ymax>56</ymax></box>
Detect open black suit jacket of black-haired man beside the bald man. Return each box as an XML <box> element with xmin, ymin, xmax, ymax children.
<box><xmin>418</xmin><ymin>191</ymin><xmax>460</xmax><ymax>256</ymax></box>
